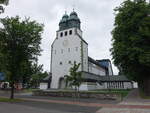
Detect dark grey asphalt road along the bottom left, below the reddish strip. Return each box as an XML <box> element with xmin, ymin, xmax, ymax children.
<box><xmin>0</xmin><ymin>101</ymin><xmax>100</xmax><ymax>113</ymax></box>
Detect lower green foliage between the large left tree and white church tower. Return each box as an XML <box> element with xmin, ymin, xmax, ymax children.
<box><xmin>21</xmin><ymin>62</ymin><xmax>49</xmax><ymax>88</ymax></box>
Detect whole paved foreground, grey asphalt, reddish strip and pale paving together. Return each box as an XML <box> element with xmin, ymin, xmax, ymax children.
<box><xmin>0</xmin><ymin>90</ymin><xmax>150</xmax><ymax>113</ymax></box>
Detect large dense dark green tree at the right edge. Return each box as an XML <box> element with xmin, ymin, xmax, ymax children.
<box><xmin>111</xmin><ymin>0</ymin><xmax>150</xmax><ymax>96</ymax></box>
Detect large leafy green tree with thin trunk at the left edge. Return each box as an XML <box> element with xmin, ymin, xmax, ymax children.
<box><xmin>0</xmin><ymin>16</ymin><xmax>43</xmax><ymax>99</ymax></box>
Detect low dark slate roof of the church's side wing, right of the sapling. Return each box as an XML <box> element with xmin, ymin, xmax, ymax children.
<box><xmin>82</xmin><ymin>72</ymin><xmax>130</xmax><ymax>82</ymax></box>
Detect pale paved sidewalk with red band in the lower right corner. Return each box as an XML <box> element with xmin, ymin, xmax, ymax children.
<box><xmin>96</xmin><ymin>89</ymin><xmax>150</xmax><ymax>113</ymax></box>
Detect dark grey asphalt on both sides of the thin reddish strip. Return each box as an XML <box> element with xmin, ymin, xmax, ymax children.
<box><xmin>0</xmin><ymin>93</ymin><xmax>118</xmax><ymax>113</ymax></box>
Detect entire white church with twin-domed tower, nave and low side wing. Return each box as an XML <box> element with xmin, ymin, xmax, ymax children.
<box><xmin>40</xmin><ymin>11</ymin><xmax>133</xmax><ymax>90</ymax></box>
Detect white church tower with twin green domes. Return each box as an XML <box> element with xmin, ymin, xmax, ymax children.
<box><xmin>51</xmin><ymin>11</ymin><xmax>88</xmax><ymax>89</ymax></box>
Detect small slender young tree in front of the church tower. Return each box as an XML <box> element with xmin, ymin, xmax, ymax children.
<box><xmin>65</xmin><ymin>62</ymin><xmax>83</xmax><ymax>96</ymax></box>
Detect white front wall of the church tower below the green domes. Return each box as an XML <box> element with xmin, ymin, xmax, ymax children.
<box><xmin>51</xmin><ymin>28</ymin><xmax>81</xmax><ymax>88</ymax></box>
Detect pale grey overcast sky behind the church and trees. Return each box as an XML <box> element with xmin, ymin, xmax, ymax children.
<box><xmin>0</xmin><ymin>0</ymin><xmax>127</xmax><ymax>74</ymax></box>
